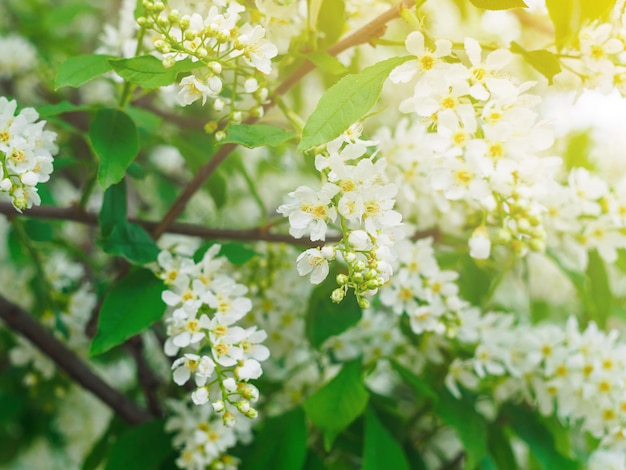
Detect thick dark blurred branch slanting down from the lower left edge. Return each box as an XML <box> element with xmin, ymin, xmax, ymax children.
<box><xmin>0</xmin><ymin>296</ymin><xmax>153</xmax><ymax>424</ymax></box>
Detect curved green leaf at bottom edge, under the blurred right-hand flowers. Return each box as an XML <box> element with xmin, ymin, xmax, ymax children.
<box><xmin>435</xmin><ymin>390</ymin><xmax>488</xmax><ymax>469</ymax></box>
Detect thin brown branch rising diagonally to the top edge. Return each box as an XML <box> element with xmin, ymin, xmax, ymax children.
<box><xmin>152</xmin><ymin>0</ymin><xmax>415</xmax><ymax>238</ymax></box>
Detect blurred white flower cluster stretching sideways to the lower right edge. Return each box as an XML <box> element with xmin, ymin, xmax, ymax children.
<box><xmin>446</xmin><ymin>311</ymin><xmax>626</xmax><ymax>445</ymax></box>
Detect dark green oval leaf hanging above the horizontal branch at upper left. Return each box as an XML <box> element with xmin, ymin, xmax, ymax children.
<box><xmin>89</xmin><ymin>109</ymin><xmax>139</xmax><ymax>189</ymax></box>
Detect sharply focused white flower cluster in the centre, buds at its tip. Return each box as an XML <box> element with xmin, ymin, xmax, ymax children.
<box><xmin>278</xmin><ymin>130</ymin><xmax>402</xmax><ymax>307</ymax></box>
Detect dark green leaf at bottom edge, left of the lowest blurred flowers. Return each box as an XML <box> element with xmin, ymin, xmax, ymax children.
<box><xmin>105</xmin><ymin>420</ymin><xmax>174</xmax><ymax>470</ymax></box>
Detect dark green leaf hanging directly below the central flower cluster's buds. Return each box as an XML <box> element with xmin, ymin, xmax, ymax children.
<box><xmin>305</xmin><ymin>272</ymin><xmax>362</xmax><ymax>349</ymax></box>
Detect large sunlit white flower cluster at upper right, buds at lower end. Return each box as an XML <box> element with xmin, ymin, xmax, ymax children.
<box><xmin>389</xmin><ymin>31</ymin><xmax>560</xmax><ymax>258</ymax></box>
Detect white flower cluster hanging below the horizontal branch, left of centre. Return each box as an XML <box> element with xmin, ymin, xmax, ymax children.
<box><xmin>158</xmin><ymin>245</ymin><xmax>269</xmax><ymax>426</ymax></box>
